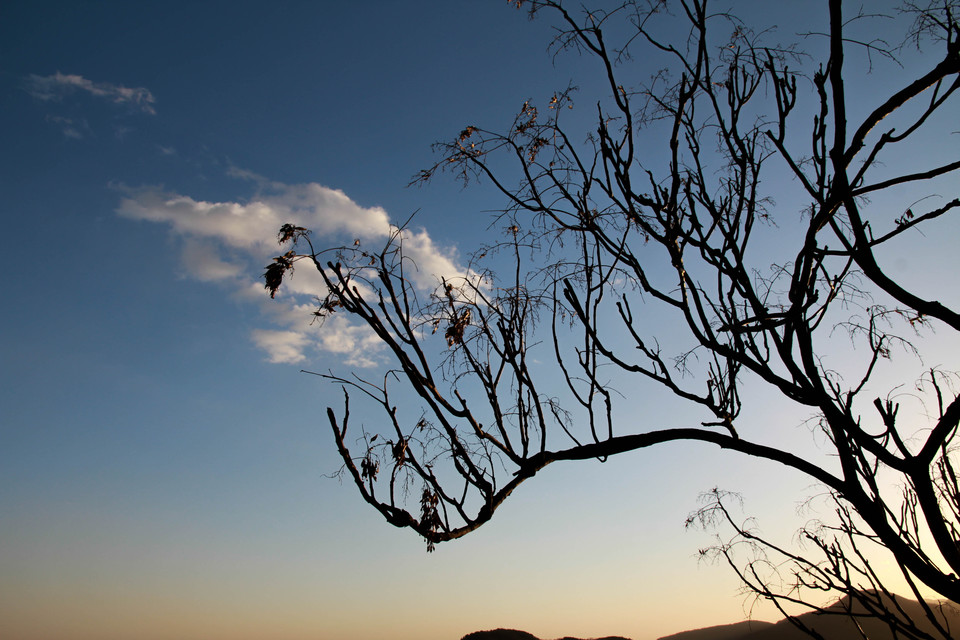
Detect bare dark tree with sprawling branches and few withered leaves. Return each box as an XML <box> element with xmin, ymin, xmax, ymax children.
<box><xmin>266</xmin><ymin>0</ymin><xmax>960</xmax><ymax>638</ymax></box>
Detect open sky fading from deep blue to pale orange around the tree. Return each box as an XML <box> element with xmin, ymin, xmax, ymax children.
<box><xmin>0</xmin><ymin>0</ymin><xmax>960</xmax><ymax>640</ymax></box>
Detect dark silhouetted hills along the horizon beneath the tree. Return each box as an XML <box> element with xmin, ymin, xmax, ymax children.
<box><xmin>461</xmin><ymin>597</ymin><xmax>960</xmax><ymax>640</ymax></box>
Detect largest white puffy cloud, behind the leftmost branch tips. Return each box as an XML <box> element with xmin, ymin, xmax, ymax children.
<box><xmin>117</xmin><ymin>169</ymin><xmax>465</xmax><ymax>367</ymax></box>
